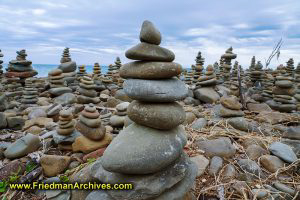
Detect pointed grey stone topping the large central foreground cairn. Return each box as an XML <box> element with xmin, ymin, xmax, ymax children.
<box><xmin>140</xmin><ymin>20</ymin><xmax>161</xmax><ymax>45</ymax></box>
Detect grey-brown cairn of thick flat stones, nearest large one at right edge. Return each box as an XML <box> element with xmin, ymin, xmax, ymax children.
<box><xmin>267</xmin><ymin>68</ymin><xmax>297</xmax><ymax>112</ymax></box>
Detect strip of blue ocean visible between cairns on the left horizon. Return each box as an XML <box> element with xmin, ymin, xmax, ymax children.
<box><xmin>3</xmin><ymin>64</ymin><xmax>108</xmax><ymax>77</ymax></box>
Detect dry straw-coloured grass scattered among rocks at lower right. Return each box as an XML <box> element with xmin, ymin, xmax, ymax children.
<box><xmin>185</xmin><ymin>113</ymin><xmax>300</xmax><ymax>199</ymax></box>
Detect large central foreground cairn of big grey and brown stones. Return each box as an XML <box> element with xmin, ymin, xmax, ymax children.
<box><xmin>86</xmin><ymin>21</ymin><xmax>197</xmax><ymax>200</ymax></box>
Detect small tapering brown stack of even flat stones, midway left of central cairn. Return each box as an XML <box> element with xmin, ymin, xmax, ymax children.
<box><xmin>77</xmin><ymin>76</ymin><xmax>100</xmax><ymax>104</ymax></box>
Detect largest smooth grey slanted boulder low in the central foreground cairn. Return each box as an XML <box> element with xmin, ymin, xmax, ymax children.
<box><xmin>102</xmin><ymin>123</ymin><xmax>187</xmax><ymax>174</ymax></box>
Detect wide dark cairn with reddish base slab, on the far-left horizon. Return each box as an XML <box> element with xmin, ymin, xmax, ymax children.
<box><xmin>5</xmin><ymin>49</ymin><xmax>38</xmax><ymax>80</ymax></box>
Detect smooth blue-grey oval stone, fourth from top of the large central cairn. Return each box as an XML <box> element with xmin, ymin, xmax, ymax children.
<box><xmin>123</xmin><ymin>78</ymin><xmax>188</xmax><ymax>102</ymax></box>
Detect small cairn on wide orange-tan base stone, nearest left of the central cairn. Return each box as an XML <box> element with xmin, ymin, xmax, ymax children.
<box><xmin>72</xmin><ymin>104</ymin><xmax>112</xmax><ymax>153</ymax></box>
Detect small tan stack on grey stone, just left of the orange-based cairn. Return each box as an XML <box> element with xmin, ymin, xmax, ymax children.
<box><xmin>53</xmin><ymin>109</ymin><xmax>80</xmax><ymax>150</ymax></box>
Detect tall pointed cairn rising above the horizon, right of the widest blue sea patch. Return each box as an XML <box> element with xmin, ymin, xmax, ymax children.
<box><xmin>58</xmin><ymin>47</ymin><xmax>77</xmax><ymax>89</ymax></box>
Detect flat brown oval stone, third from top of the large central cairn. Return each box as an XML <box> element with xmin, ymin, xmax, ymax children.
<box><xmin>120</xmin><ymin>61</ymin><xmax>182</xmax><ymax>79</ymax></box>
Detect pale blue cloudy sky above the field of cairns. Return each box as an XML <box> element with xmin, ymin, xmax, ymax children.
<box><xmin>0</xmin><ymin>0</ymin><xmax>300</xmax><ymax>67</ymax></box>
